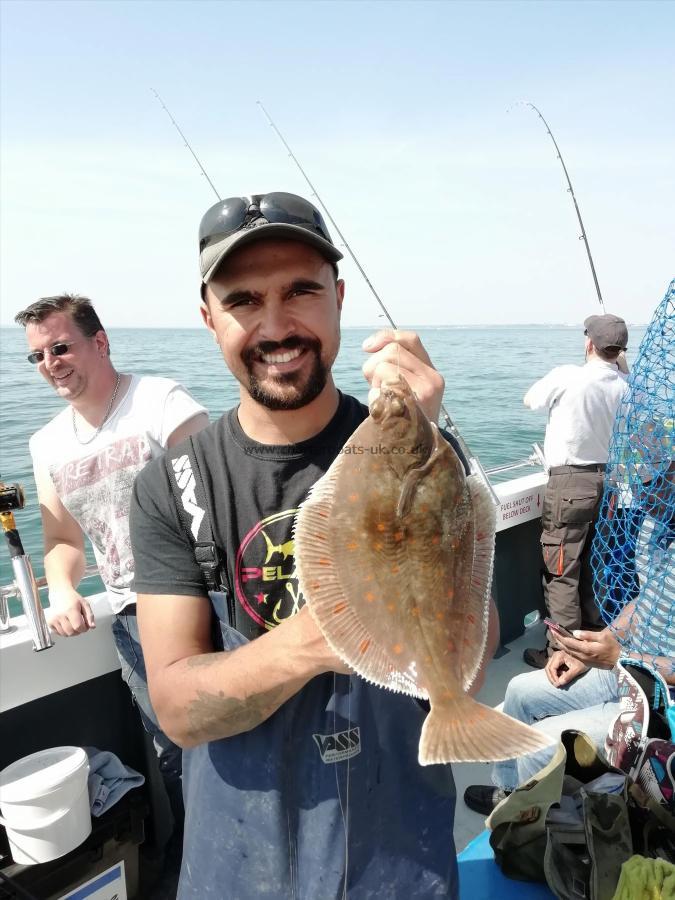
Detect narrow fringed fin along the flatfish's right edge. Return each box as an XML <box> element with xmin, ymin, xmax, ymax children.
<box><xmin>460</xmin><ymin>475</ymin><xmax>497</xmax><ymax>691</ymax></box>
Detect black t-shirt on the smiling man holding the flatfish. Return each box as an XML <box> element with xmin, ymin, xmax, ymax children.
<box><xmin>131</xmin><ymin>394</ymin><xmax>368</xmax><ymax>638</ymax></box>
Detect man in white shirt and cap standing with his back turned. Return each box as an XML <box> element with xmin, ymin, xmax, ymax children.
<box><xmin>523</xmin><ymin>314</ymin><xmax>628</xmax><ymax>668</ymax></box>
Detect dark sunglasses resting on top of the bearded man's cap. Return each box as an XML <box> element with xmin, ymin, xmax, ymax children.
<box><xmin>199</xmin><ymin>191</ymin><xmax>333</xmax><ymax>253</ymax></box>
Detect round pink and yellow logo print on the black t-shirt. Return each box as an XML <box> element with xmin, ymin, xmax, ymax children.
<box><xmin>234</xmin><ymin>509</ymin><xmax>305</xmax><ymax>629</ymax></box>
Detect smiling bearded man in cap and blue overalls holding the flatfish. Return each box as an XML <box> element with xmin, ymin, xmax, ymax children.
<box><xmin>131</xmin><ymin>193</ymin><xmax>476</xmax><ymax>900</ymax></box>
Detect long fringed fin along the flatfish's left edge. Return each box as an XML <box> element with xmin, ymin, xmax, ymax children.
<box><xmin>293</xmin><ymin>463</ymin><xmax>428</xmax><ymax>698</ymax></box>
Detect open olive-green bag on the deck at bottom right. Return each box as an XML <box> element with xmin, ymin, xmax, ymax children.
<box><xmin>486</xmin><ymin>730</ymin><xmax>675</xmax><ymax>900</ymax></box>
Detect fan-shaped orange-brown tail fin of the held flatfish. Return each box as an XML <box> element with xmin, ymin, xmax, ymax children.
<box><xmin>419</xmin><ymin>694</ymin><xmax>553</xmax><ymax>766</ymax></box>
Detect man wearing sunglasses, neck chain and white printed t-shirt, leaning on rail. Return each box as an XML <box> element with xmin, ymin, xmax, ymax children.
<box><xmin>15</xmin><ymin>294</ymin><xmax>208</xmax><ymax>892</ymax></box>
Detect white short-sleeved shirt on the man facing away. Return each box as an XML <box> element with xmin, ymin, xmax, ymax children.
<box><xmin>523</xmin><ymin>359</ymin><xmax>628</xmax><ymax>469</ymax></box>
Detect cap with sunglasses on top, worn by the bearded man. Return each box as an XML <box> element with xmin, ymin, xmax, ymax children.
<box><xmin>199</xmin><ymin>191</ymin><xmax>342</xmax><ymax>284</ymax></box>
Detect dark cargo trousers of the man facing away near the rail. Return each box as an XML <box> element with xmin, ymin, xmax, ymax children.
<box><xmin>541</xmin><ymin>467</ymin><xmax>604</xmax><ymax>647</ymax></box>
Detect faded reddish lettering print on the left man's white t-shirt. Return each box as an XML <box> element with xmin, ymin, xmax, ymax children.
<box><xmin>50</xmin><ymin>434</ymin><xmax>152</xmax><ymax>589</ymax></box>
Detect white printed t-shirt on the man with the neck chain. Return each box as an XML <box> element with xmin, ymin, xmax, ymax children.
<box><xmin>30</xmin><ymin>375</ymin><xmax>206</xmax><ymax>613</ymax></box>
